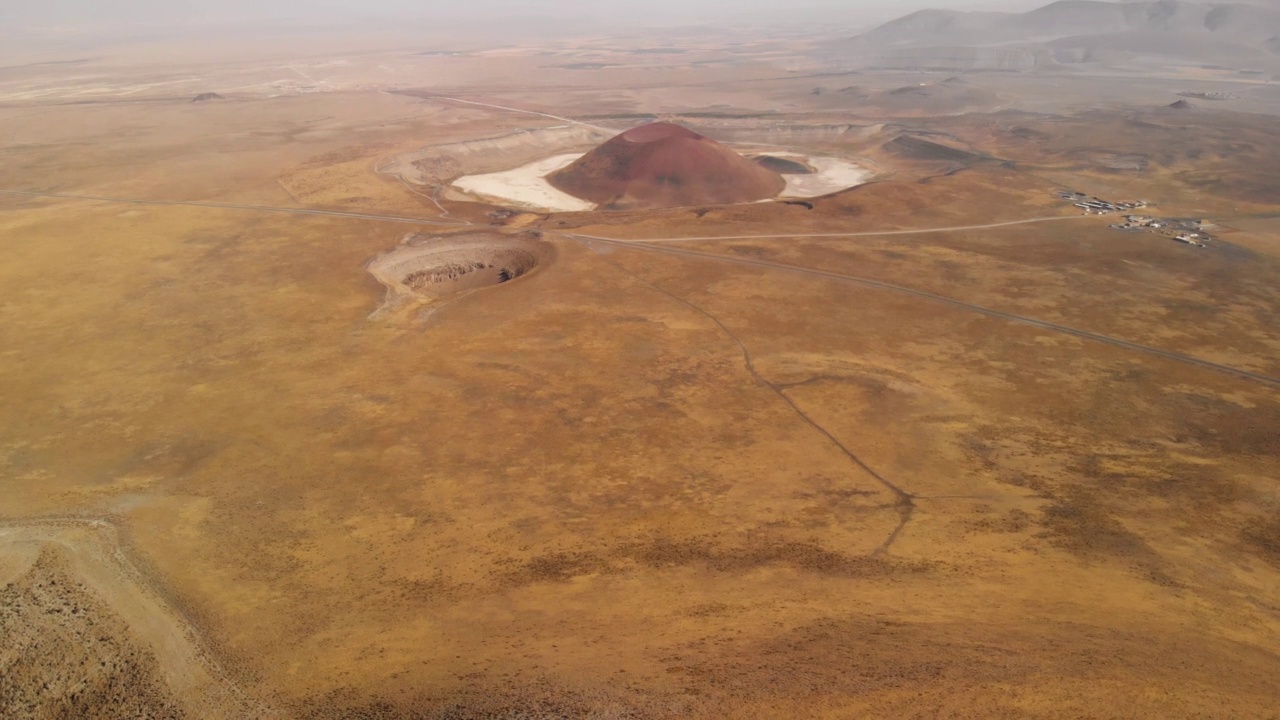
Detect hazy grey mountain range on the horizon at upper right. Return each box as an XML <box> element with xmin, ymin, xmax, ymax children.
<box><xmin>827</xmin><ymin>0</ymin><xmax>1280</xmax><ymax>74</ymax></box>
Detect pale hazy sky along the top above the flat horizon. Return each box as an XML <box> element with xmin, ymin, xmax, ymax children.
<box><xmin>0</xmin><ymin>0</ymin><xmax>1047</xmax><ymax>28</ymax></box>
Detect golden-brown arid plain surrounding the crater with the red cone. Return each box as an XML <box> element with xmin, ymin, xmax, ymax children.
<box><xmin>0</xmin><ymin>22</ymin><xmax>1280</xmax><ymax>720</ymax></box>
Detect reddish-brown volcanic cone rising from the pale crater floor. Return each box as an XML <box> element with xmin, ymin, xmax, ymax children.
<box><xmin>547</xmin><ymin>123</ymin><xmax>786</xmax><ymax>209</ymax></box>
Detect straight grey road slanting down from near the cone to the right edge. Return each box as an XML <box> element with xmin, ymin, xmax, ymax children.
<box><xmin>561</xmin><ymin>230</ymin><xmax>1280</xmax><ymax>387</ymax></box>
